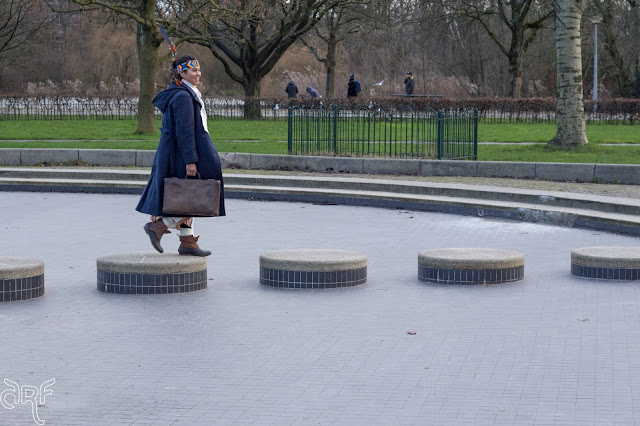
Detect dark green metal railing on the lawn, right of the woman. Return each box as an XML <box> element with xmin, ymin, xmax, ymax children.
<box><xmin>288</xmin><ymin>106</ymin><xmax>478</xmax><ymax>160</ymax></box>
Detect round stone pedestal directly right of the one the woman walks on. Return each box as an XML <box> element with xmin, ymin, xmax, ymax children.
<box><xmin>260</xmin><ymin>249</ymin><xmax>367</xmax><ymax>289</ymax></box>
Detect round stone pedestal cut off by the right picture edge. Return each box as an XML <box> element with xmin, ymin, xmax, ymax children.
<box><xmin>571</xmin><ymin>246</ymin><xmax>640</xmax><ymax>281</ymax></box>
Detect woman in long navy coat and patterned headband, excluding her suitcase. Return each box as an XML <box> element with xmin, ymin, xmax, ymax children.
<box><xmin>136</xmin><ymin>55</ymin><xmax>225</xmax><ymax>256</ymax></box>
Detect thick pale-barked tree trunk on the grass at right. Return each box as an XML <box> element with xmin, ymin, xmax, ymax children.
<box><xmin>549</xmin><ymin>0</ymin><xmax>588</xmax><ymax>147</ymax></box>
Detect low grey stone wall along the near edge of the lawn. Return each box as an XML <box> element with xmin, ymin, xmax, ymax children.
<box><xmin>0</xmin><ymin>148</ymin><xmax>640</xmax><ymax>185</ymax></box>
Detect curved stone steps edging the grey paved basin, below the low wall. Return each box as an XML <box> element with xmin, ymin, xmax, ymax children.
<box><xmin>0</xmin><ymin>168</ymin><xmax>640</xmax><ymax>235</ymax></box>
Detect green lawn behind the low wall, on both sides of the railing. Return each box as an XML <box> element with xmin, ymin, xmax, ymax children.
<box><xmin>0</xmin><ymin>120</ymin><xmax>640</xmax><ymax>164</ymax></box>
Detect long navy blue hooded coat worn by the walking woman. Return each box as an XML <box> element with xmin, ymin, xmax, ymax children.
<box><xmin>136</xmin><ymin>83</ymin><xmax>225</xmax><ymax>216</ymax></box>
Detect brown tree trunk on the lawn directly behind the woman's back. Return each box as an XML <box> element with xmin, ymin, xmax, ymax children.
<box><xmin>136</xmin><ymin>24</ymin><xmax>160</xmax><ymax>133</ymax></box>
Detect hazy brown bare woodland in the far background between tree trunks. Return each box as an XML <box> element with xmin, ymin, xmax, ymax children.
<box><xmin>0</xmin><ymin>0</ymin><xmax>640</xmax><ymax>99</ymax></box>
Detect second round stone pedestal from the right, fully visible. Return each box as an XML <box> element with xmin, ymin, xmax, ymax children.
<box><xmin>418</xmin><ymin>248</ymin><xmax>524</xmax><ymax>284</ymax></box>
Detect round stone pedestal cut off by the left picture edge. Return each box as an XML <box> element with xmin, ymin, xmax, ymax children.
<box><xmin>0</xmin><ymin>256</ymin><xmax>44</xmax><ymax>302</ymax></box>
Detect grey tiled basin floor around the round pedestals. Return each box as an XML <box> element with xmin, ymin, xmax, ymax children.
<box><xmin>0</xmin><ymin>192</ymin><xmax>640</xmax><ymax>425</ymax></box>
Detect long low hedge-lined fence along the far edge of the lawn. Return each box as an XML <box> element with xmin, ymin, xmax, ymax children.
<box><xmin>0</xmin><ymin>95</ymin><xmax>640</xmax><ymax>125</ymax></box>
